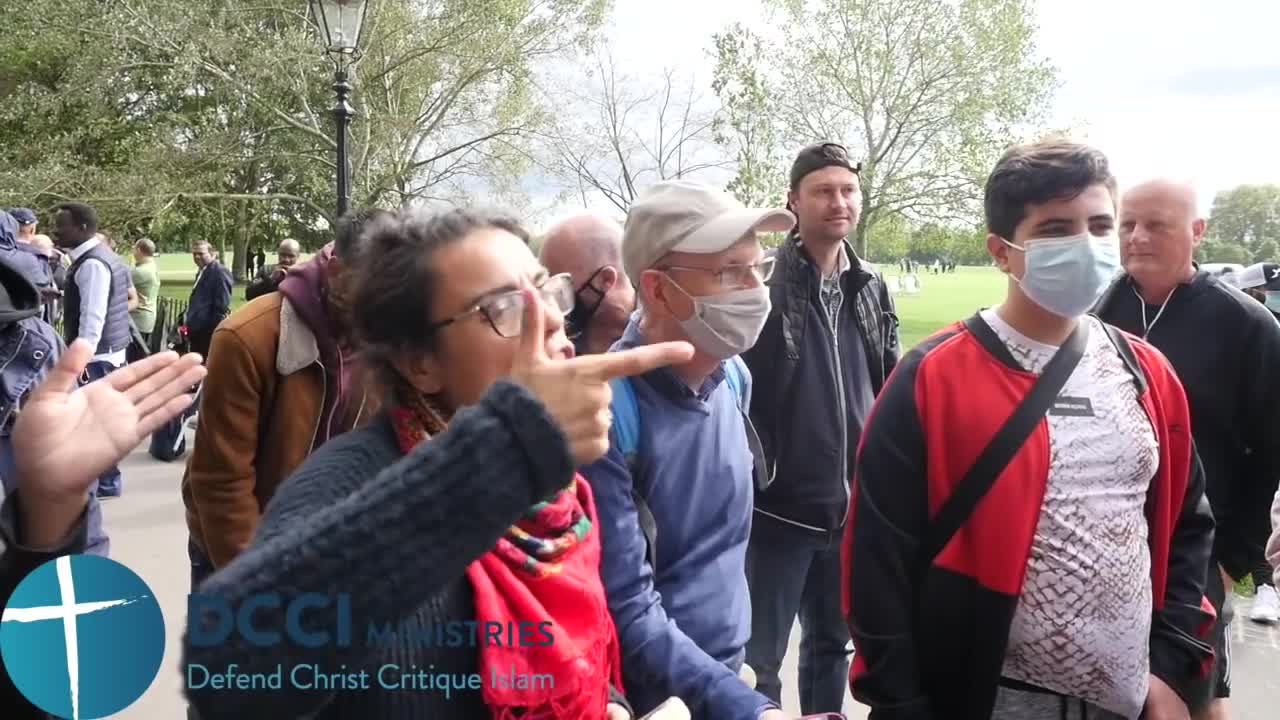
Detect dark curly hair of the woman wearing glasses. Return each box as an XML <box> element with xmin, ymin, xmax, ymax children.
<box><xmin>352</xmin><ymin>209</ymin><xmax>529</xmax><ymax>380</ymax></box>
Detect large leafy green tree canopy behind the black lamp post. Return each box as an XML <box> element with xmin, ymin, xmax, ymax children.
<box><xmin>0</xmin><ymin>0</ymin><xmax>609</xmax><ymax>277</ymax></box>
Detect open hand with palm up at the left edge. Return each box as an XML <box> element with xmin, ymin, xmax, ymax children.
<box><xmin>12</xmin><ymin>341</ymin><xmax>205</xmax><ymax>500</ymax></box>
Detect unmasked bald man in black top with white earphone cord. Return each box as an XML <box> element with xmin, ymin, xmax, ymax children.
<box><xmin>1096</xmin><ymin>179</ymin><xmax>1280</xmax><ymax>719</ymax></box>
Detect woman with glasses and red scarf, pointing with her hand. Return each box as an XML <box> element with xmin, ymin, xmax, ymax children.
<box><xmin>183</xmin><ymin>210</ymin><xmax>692</xmax><ymax>720</ymax></box>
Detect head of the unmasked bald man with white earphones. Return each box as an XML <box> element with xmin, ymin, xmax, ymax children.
<box><xmin>1120</xmin><ymin>178</ymin><xmax>1206</xmax><ymax>302</ymax></box>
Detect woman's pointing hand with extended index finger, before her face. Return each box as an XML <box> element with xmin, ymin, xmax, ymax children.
<box><xmin>511</xmin><ymin>290</ymin><xmax>694</xmax><ymax>465</ymax></box>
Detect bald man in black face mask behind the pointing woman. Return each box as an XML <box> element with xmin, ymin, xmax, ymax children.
<box><xmin>539</xmin><ymin>213</ymin><xmax>636</xmax><ymax>354</ymax></box>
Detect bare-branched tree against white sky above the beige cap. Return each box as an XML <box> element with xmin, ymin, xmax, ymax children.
<box><xmin>548</xmin><ymin>49</ymin><xmax>724</xmax><ymax>213</ymax></box>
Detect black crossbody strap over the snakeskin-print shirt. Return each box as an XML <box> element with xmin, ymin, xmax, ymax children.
<box><xmin>920</xmin><ymin>318</ymin><xmax>1093</xmax><ymax>565</ymax></box>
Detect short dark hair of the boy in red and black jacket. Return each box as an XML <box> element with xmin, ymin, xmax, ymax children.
<box><xmin>983</xmin><ymin>140</ymin><xmax>1116</xmax><ymax>242</ymax></box>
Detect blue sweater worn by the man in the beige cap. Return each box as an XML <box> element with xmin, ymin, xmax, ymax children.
<box><xmin>582</xmin><ymin>315</ymin><xmax>772</xmax><ymax>720</ymax></box>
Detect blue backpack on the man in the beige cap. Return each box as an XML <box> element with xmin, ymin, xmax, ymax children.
<box><xmin>609</xmin><ymin>356</ymin><xmax>772</xmax><ymax>570</ymax></box>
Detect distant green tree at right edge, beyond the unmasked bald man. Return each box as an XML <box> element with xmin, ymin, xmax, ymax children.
<box><xmin>1207</xmin><ymin>184</ymin><xmax>1280</xmax><ymax>263</ymax></box>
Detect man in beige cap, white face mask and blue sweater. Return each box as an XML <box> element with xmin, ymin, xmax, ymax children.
<box><xmin>582</xmin><ymin>181</ymin><xmax>795</xmax><ymax>720</ymax></box>
